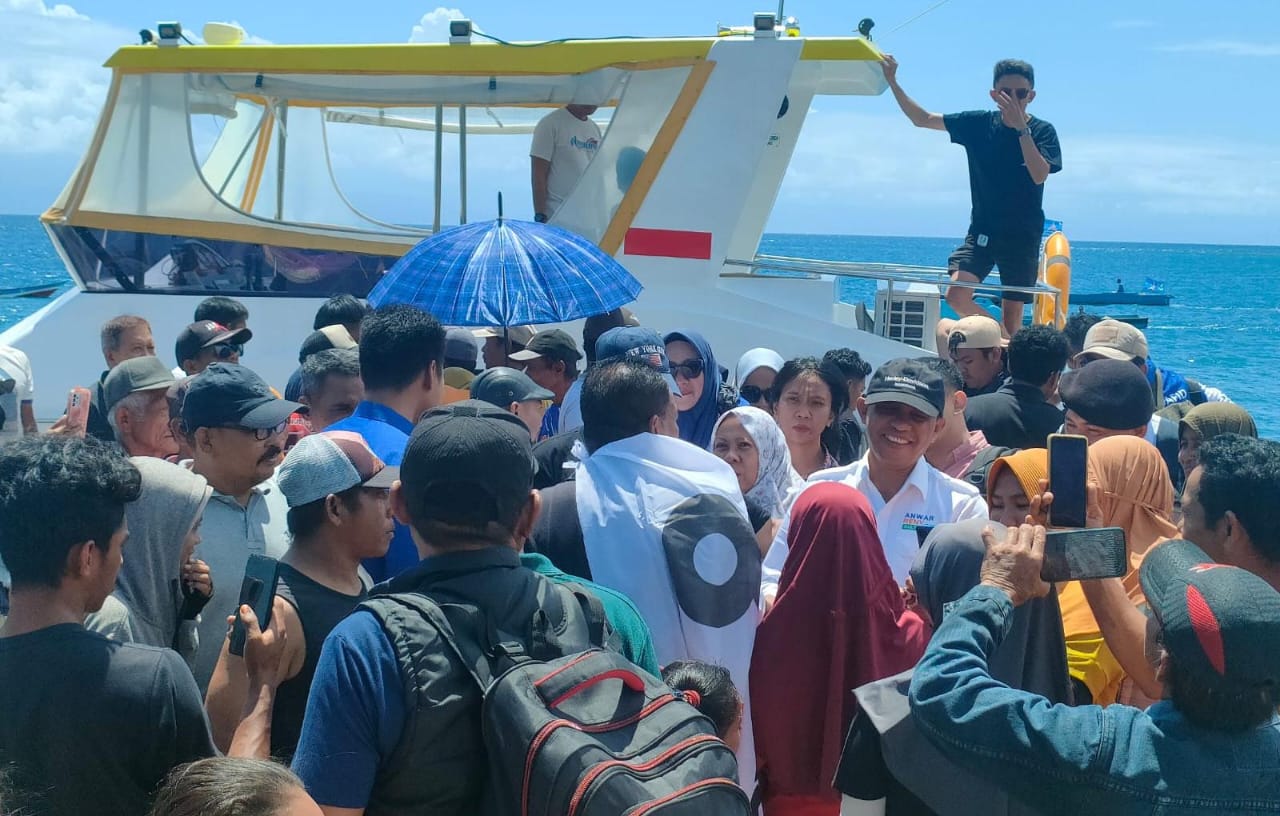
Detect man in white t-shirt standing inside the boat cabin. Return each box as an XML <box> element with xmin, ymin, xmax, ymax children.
<box><xmin>529</xmin><ymin>105</ymin><xmax>600</xmax><ymax>224</ymax></box>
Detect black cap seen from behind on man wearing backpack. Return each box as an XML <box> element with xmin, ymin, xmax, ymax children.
<box><xmin>401</xmin><ymin>398</ymin><xmax>538</xmax><ymax>524</ymax></box>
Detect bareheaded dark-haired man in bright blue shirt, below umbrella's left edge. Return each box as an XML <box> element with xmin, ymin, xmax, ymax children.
<box><xmin>326</xmin><ymin>306</ymin><xmax>444</xmax><ymax>582</ymax></box>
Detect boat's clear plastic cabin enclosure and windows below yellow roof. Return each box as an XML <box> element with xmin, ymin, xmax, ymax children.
<box><xmin>49</xmin><ymin>61</ymin><xmax>692</xmax><ymax>297</ymax></box>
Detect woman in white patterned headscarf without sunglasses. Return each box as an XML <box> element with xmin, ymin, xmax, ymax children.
<box><xmin>712</xmin><ymin>407</ymin><xmax>804</xmax><ymax>554</ymax></box>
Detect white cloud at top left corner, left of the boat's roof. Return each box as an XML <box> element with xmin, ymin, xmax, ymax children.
<box><xmin>0</xmin><ymin>0</ymin><xmax>128</xmax><ymax>155</ymax></box>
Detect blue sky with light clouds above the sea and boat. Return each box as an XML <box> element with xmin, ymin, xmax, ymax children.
<box><xmin>0</xmin><ymin>0</ymin><xmax>1280</xmax><ymax>244</ymax></box>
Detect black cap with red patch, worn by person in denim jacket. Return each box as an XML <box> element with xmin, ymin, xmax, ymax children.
<box><xmin>1136</xmin><ymin>539</ymin><xmax>1280</xmax><ymax>691</ymax></box>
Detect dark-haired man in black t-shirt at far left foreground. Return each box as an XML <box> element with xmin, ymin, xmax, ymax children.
<box><xmin>0</xmin><ymin>435</ymin><xmax>280</xmax><ymax>816</ymax></box>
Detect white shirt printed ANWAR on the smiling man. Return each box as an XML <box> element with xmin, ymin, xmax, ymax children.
<box><xmin>760</xmin><ymin>455</ymin><xmax>987</xmax><ymax>596</ymax></box>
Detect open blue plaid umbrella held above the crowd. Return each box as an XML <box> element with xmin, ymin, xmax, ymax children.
<box><xmin>369</xmin><ymin>200</ymin><xmax>643</xmax><ymax>326</ymax></box>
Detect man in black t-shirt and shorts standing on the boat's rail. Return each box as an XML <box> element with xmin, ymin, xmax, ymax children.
<box><xmin>882</xmin><ymin>54</ymin><xmax>1062</xmax><ymax>336</ymax></box>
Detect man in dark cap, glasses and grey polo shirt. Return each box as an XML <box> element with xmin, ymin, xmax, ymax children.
<box><xmin>182</xmin><ymin>363</ymin><xmax>300</xmax><ymax>694</ymax></box>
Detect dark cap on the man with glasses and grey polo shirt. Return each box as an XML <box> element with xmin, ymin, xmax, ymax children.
<box><xmin>182</xmin><ymin>363</ymin><xmax>302</xmax><ymax>432</ymax></box>
